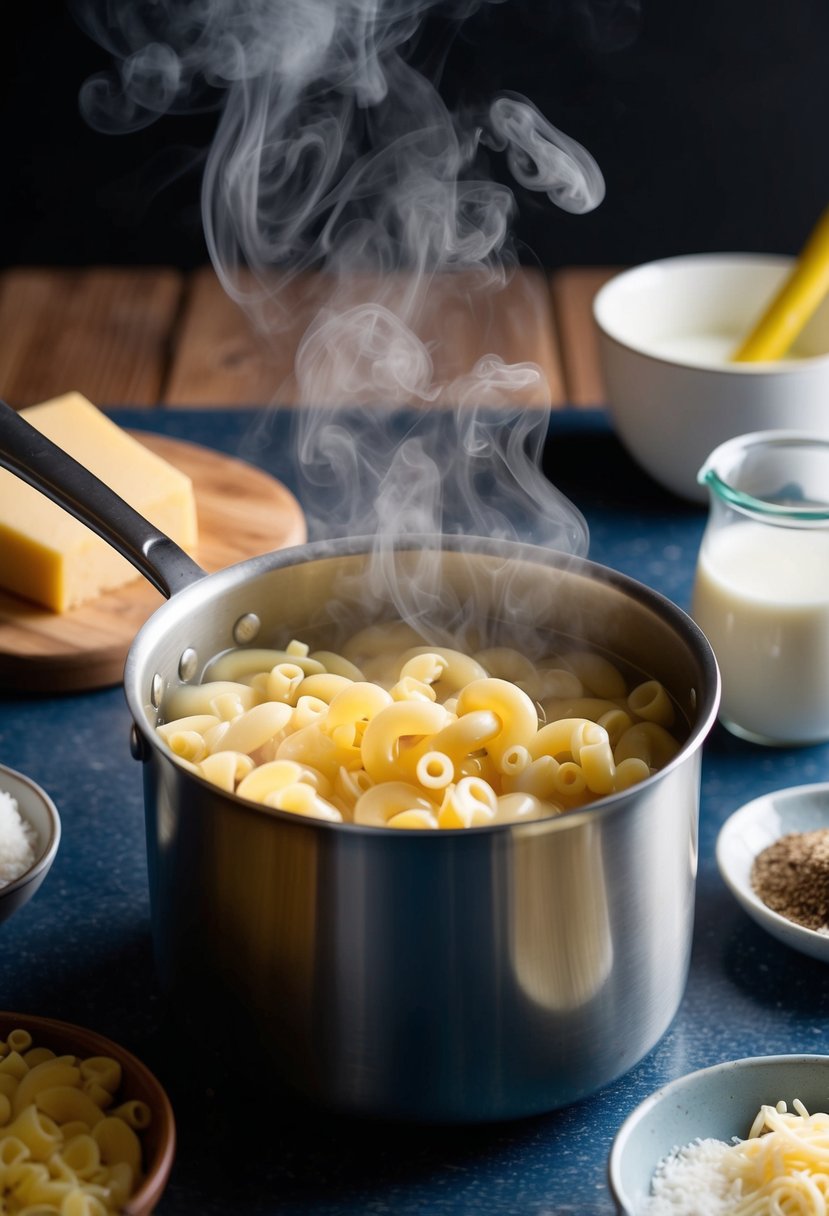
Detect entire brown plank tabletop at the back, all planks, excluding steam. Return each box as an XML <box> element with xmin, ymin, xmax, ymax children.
<box><xmin>0</xmin><ymin>266</ymin><xmax>614</xmax><ymax>409</ymax></box>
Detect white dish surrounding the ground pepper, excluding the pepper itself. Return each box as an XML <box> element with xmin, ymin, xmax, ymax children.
<box><xmin>717</xmin><ymin>783</ymin><xmax>829</xmax><ymax>963</ymax></box>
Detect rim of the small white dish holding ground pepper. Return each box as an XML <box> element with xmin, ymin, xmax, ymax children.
<box><xmin>715</xmin><ymin>781</ymin><xmax>829</xmax><ymax>962</ymax></box>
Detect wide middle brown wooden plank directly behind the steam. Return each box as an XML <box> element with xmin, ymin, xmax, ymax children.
<box><xmin>164</xmin><ymin>269</ymin><xmax>566</xmax><ymax>406</ymax></box>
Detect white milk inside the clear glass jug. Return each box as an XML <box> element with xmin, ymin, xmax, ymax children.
<box><xmin>692</xmin><ymin>520</ymin><xmax>829</xmax><ymax>743</ymax></box>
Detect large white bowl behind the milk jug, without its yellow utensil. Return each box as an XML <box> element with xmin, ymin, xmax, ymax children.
<box><xmin>593</xmin><ymin>253</ymin><xmax>829</xmax><ymax>502</ymax></box>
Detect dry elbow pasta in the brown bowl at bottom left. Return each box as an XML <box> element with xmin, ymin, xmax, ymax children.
<box><xmin>0</xmin><ymin>1029</ymin><xmax>151</xmax><ymax>1216</ymax></box>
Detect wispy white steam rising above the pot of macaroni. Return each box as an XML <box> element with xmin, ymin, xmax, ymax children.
<box><xmin>79</xmin><ymin>0</ymin><xmax>604</xmax><ymax>588</ymax></box>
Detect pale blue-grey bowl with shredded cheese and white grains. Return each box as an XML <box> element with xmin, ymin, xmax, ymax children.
<box><xmin>609</xmin><ymin>1055</ymin><xmax>829</xmax><ymax>1216</ymax></box>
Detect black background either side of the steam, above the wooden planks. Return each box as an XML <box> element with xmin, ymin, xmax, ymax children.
<box><xmin>6</xmin><ymin>0</ymin><xmax>829</xmax><ymax>268</ymax></box>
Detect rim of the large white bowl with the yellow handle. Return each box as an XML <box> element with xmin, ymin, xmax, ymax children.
<box><xmin>591</xmin><ymin>252</ymin><xmax>829</xmax><ymax>377</ymax></box>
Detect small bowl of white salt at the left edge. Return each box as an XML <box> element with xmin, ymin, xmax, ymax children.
<box><xmin>0</xmin><ymin>765</ymin><xmax>61</xmax><ymax>922</ymax></box>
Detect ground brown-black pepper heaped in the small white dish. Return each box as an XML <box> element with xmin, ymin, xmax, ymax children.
<box><xmin>751</xmin><ymin>828</ymin><xmax>829</xmax><ymax>934</ymax></box>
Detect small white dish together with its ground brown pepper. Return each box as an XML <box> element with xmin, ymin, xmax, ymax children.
<box><xmin>717</xmin><ymin>783</ymin><xmax>829</xmax><ymax>962</ymax></box>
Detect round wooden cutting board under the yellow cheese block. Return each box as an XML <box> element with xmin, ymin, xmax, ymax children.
<box><xmin>0</xmin><ymin>430</ymin><xmax>306</xmax><ymax>694</ymax></box>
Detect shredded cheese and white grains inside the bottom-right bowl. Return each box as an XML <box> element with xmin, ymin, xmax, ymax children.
<box><xmin>642</xmin><ymin>1100</ymin><xmax>829</xmax><ymax>1216</ymax></box>
